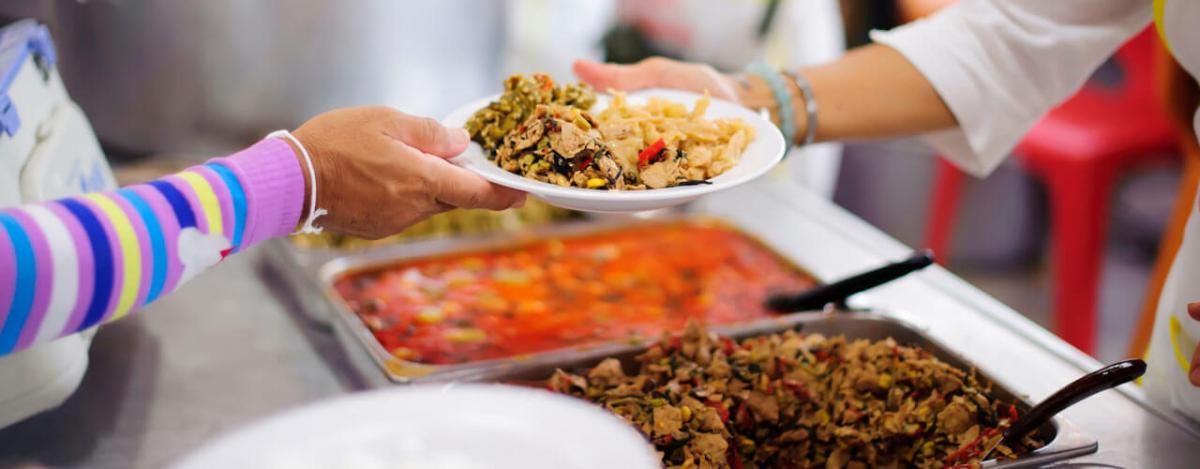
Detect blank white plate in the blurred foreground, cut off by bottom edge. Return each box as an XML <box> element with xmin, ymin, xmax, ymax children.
<box><xmin>175</xmin><ymin>384</ymin><xmax>660</xmax><ymax>469</ymax></box>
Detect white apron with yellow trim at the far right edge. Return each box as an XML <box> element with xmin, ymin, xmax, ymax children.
<box><xmin>1144</xmin><ymin>0</ymin><xmax>1200</xmax><ymax>422</ymax></box>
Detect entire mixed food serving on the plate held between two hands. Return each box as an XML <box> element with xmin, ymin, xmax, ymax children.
<box><xmin>467</xmin><ymin>74</ymin><xmax>755</xmax><ymax>191</ymax></box>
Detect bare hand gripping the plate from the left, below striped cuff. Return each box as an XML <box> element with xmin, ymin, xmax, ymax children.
<box><xmin>293</xmin><ymin>107</ymin><xmax>526</xmax><ymax>239</ymax></box>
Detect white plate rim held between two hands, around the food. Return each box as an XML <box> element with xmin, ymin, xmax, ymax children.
<box><xmin>443</xmin><ymin>89</ymin><xmax>787</xmax><ymax>212</ymax></box>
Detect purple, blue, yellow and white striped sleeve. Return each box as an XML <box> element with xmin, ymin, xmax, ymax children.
<box><xmin>0</xmin><ymin>138</ymin><xmax>305</xmax><ymax>355</ymax></box>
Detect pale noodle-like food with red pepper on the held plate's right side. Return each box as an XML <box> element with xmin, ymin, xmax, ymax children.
<box><xmin>596</xmin><ymin>92</ymin><xmax>755</xmax><ymax>188</ymax></box>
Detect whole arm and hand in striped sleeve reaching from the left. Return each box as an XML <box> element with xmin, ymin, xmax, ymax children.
<box><xmin>0</xmin><ymin>108</ymin><xmax>524</xmax><ymax>355</ymax></box>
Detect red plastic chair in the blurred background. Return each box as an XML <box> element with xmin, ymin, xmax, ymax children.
<box><xmin>926</xmin><ymin>28</ymin><xmax>1178</xmax><ymax>353</ymax></box>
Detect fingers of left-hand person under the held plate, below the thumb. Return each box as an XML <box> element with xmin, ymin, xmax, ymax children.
<box><xmin>425</xmin><ymin>154</ymin><xmax>526</xmax><ymax>210</ymax></box>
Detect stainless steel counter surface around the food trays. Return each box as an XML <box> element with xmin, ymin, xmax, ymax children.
<box><xmin>0</xmin><ymin>174</ymin><xmax>1200</xmax><ymax>468</ymax></box>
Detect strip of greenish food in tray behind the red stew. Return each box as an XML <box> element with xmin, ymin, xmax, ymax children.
<box><xmin>290</xmin><ymin>198</ymin><xmax>573</xmax><ymax>249</ymax></box>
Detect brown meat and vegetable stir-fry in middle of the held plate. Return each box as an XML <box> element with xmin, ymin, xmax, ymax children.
<box><xmin>496</xmin><ymin>104</ymin><xmax>625</xmax><ymax>190</ymax></box>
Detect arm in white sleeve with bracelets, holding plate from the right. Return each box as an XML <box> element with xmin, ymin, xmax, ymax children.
<box><xmin>575</xmin><ymin>0</ymin><xmax>1151</xmax><ymax>175</ymax></box>
